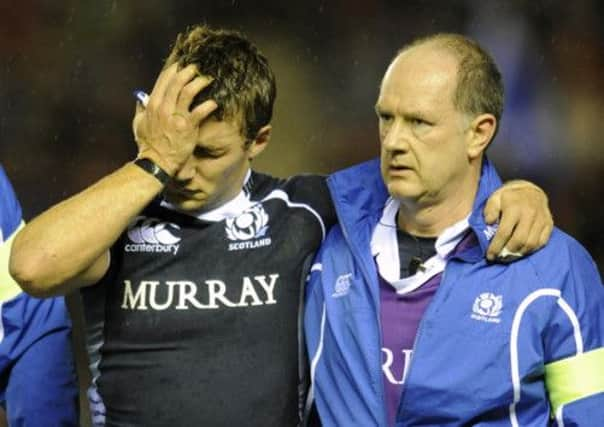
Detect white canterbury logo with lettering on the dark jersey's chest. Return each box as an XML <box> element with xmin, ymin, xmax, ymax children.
<box><xmin>124</xmin><ymin>216</ymin><xmax>181</xmax><ymax>255</ymax></box>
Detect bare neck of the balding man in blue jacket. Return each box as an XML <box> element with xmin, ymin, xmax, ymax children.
<box><xmin>397</xmin><ymin>166</ymin><xmax>478</xmax><ymax>237</ymax></box>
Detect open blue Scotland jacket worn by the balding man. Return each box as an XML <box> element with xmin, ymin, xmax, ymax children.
<box><xmin>305</xmin><ymin>160</ymin><xmax>604</xmax><ymax>427</ymax></box>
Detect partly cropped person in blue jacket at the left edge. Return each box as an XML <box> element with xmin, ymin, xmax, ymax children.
<box><xmin>0</xmin><ymin>167</ymin><xmax>79</xmax><ymax>427</ymax></box>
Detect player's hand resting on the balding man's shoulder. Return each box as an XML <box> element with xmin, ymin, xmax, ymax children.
<box><xmin>484</xmin><ymin>180</ymin><xmax>554</xmax><ymax>261</ymax></box>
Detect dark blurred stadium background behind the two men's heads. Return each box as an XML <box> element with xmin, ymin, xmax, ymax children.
<box><xmin>0</xmin><ymin>0</ymin><xmax>604</xmax><ymax>424</ymax></box>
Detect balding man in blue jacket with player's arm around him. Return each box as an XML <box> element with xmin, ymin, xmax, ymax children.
<box><xmin>305</xmin><ymin>34</ymin><xmax>604</xmax><ymax>427</ymax></box>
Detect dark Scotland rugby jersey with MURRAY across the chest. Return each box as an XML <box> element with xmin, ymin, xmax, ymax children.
<box><xmin>82</xmin><ymin>172</ymin><xmax>335</xmax><ymax>427</ymax></box>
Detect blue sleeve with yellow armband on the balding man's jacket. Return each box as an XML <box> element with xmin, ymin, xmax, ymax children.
<box><xmin>545</xmin><ymin>239</ymin><xmax>604</xmax><ymax>427</ymax></box>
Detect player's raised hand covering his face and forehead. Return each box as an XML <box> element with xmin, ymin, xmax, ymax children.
<box><xmin>132</xmin><ymin>64</ymin><xmax>217</xmax><ymax>174</ymax></box>
